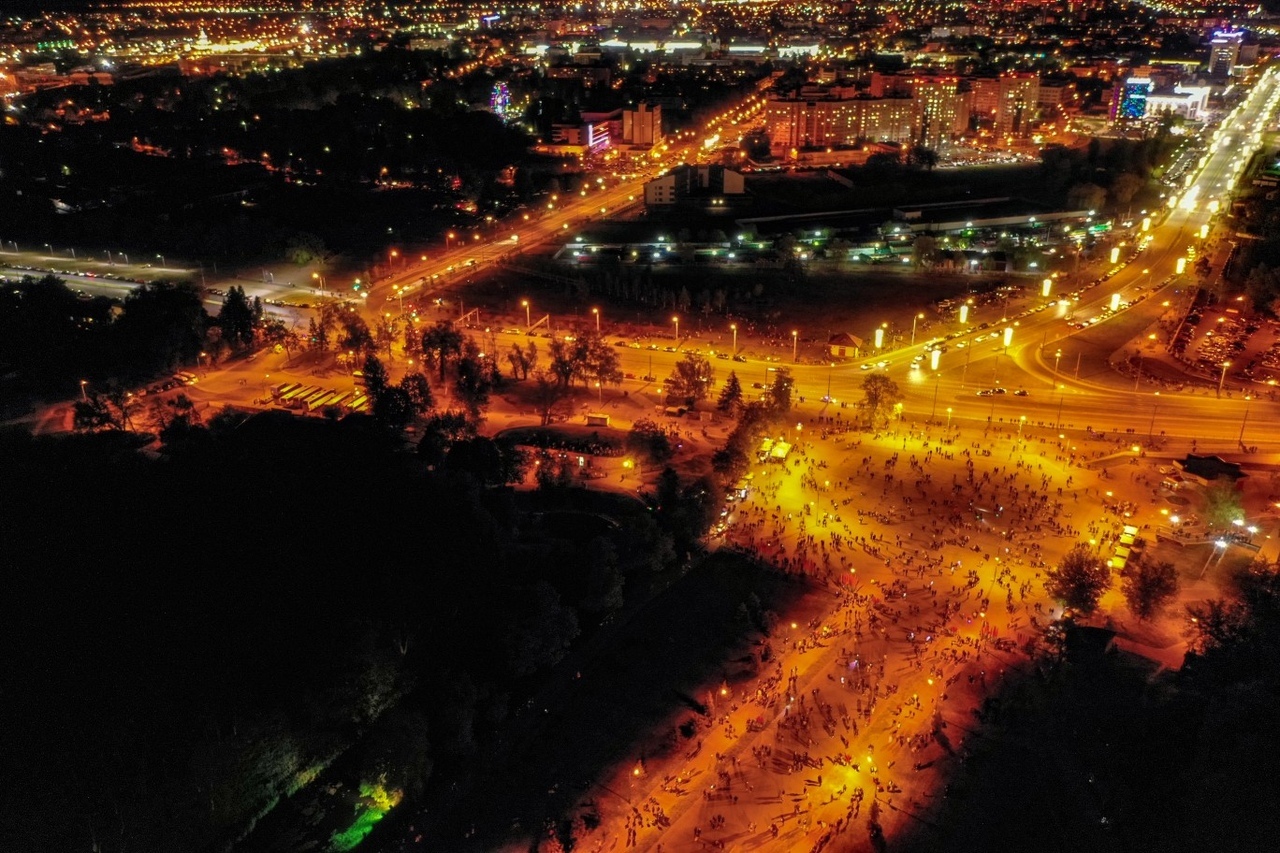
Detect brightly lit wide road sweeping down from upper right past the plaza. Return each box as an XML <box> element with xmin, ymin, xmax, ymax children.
<box><xmin>465</xmin><ymin>72</ymin><xmax>1280</xmax><ymax>451</ymax></box>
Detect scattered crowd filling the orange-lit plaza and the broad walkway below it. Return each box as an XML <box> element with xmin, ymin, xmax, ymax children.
<box><xmin>588</xmin><ymin>419</ymin><xmax>1149</xmax><ymax>852</ymax></box>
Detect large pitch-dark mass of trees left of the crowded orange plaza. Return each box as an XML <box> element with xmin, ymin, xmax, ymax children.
<box><xmin>0</xmin><ymin>414</ymin><xmax>691</xmax><ymax>853</ymax></box>
